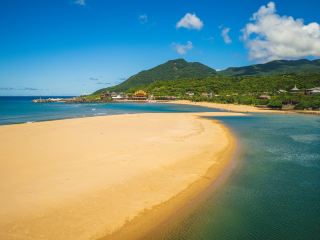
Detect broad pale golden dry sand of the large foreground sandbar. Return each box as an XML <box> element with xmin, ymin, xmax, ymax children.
<box><xmin>0</xmin><ymin>112</ymin><xmax>241</xmax><ymax>240</ymax></box>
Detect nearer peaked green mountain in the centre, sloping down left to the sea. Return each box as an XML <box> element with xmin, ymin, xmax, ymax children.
<box><xmin>96</xmin><ymin>59</ymin><xmax>216</xmax><ymax>93</ymax></box>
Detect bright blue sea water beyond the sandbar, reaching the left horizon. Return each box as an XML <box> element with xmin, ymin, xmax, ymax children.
<box><xmin>0</xmin><ymin>97</ymin><xmax>219</xmax><ymax>125</ymax></box>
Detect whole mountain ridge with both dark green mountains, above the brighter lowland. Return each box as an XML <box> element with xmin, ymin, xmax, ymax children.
<box><xmin>94</xmin><ymin>58</ymin><xmax>320</xmax><ymax>94</ymax></box>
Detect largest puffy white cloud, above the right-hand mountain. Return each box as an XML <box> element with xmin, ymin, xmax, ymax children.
<box><xmin>242</xmin><ymin>2</ymin><xmax>320</xmax><ymax>62</ymax></box>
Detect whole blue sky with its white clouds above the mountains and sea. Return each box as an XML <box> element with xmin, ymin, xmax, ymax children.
<box><xmin>0</xmin><ymin>0</ymin><xmax>320</xmax><ymax>95</ymax></box>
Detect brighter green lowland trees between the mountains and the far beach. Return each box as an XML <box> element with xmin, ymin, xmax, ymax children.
<box><xmin>120</xmin><ymin>74</ymin><xmax>320</xmax><ymax>109</ymax></box>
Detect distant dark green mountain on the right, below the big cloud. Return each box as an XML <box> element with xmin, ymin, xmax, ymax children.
<box><xmin>219</xmin><ymin>59</ymin><xmax>320</xmax><ymax>76</ymax></box>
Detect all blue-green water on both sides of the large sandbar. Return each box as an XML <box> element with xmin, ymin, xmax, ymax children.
<box><xmin>0</xmin><ymin>97</ymin><xmax>320</xmax><ymax>240</ymax></box>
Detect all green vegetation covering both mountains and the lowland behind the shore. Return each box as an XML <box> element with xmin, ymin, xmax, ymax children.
<box><xmin>88</xmin><ymin>59</ymin><xmax>320</xmax><ymax>109</ymax></box>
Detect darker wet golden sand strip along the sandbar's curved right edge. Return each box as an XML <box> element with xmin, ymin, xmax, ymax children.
<box><xmin>98</xmin><ymin>122</ymin><xmax>240</xmax><ymax>240</ymax></box>
